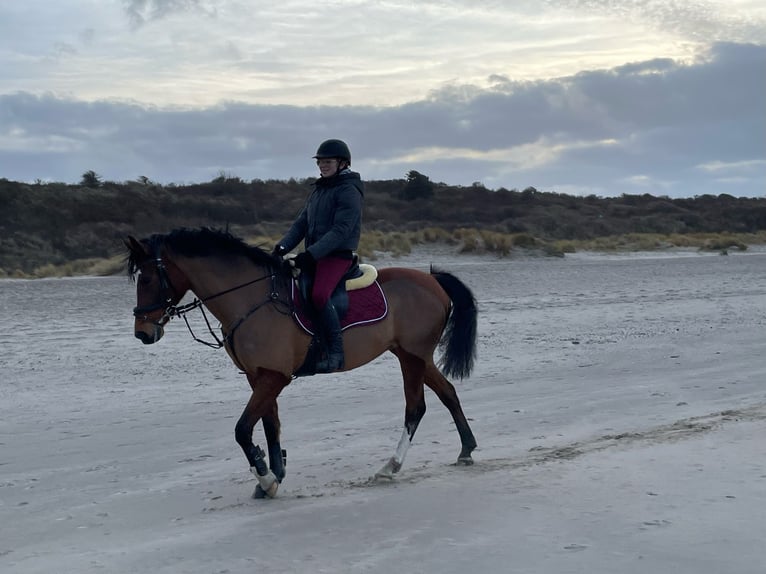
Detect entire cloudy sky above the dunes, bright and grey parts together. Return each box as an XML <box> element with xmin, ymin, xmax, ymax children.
<box><xmin>0</xmin><ymin>0</ymin><xmax>766</xmax><ymax>197</ymax></box>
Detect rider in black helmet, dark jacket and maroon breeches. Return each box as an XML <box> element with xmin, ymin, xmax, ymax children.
<box><xmin>274</xmin><ymin>139</ymin><xmax>364</xmax><ymax>372</ymax></box>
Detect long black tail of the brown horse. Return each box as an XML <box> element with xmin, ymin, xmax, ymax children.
<box><xmin>431</xmin><ymin>266</ymin><xmax>476</xmax><ymax>379</ymax></box>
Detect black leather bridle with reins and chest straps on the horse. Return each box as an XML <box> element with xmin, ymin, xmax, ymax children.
<box><xmin>133</xmin><ymin>246</ymin><xmax>293</xmax><ymax>354</ymax></box>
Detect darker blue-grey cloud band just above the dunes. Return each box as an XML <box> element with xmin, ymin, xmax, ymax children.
<box><xmin>0</xmin><ymin>44</ymin><xmax>766</xmax><ymax>196</ymax></box>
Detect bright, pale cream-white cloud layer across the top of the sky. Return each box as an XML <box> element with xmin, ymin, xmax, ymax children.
<box><xmin>0</xmin><ymin>0</ymin><xmax>766</xmax><ymax>106</ymax></box>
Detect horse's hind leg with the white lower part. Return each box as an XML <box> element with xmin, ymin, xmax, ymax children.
<box><xmin>375</xmin><ymin>349</ymin><xmax>426</xmax><ymax>478</ymax></box>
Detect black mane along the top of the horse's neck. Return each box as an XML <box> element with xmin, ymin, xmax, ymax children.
<box><xmin>126</xmin><ymin>227</ymin><xmax>280</xmax><ymax>277</ymax></box>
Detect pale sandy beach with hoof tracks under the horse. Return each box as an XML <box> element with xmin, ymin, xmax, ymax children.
<box><xmin>0</xmin><ymin>252</ymin><xmax>766</xmax><ymax>574</ymax></box>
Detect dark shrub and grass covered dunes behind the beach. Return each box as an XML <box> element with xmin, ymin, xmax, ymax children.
<box><xmin>0</xmin><ymin>176</ymin><xmax>766</xmax><ymax>277</ymax></box>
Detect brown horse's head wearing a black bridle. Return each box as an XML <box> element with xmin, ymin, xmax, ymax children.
<box><xmin>125</xmin><ymin>236</ymin><xmax>189</xmax><ymax>345</ymax></box>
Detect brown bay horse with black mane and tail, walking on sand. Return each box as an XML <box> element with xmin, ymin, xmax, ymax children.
<box><xmin>123</xmin><ymin>227</ymin><xmax>477</xmax><ymax>498</ymax></box>
